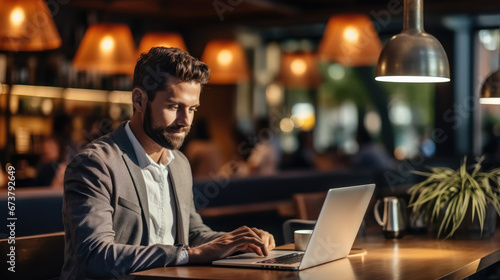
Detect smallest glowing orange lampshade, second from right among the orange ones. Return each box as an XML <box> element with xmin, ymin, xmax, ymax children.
<box><xmin>279</xmin><ymin>53</ymin><xmax>321</xmax><ymax>88</ymax></box>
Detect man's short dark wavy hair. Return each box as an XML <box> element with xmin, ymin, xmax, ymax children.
<box><xmin>133</xmin><ymin>47</ymin><xmax>210</xmax><ymax>101</ymax></box>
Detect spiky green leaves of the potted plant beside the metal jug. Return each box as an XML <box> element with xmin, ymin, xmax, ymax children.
<box><xmin>408</xmin><ymin>157</ymin><xmax>500</xmax><ymax>239</ymax></box>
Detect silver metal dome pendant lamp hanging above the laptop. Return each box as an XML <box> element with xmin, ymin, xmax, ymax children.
<box><xmin>375</xmin><ymin>0</ymin><xmax>450</xmax><ymax>83</ymax></box>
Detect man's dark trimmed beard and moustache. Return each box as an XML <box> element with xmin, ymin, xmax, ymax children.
<box><xmin>143</xmin><ymin>102</ymin><xmax>191</xmax><ymax>150</ymax></box>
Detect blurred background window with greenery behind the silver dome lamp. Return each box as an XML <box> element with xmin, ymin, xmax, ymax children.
<box><xmin>315</xmin><ymin>61</ymin><xmax>435</xmax><ymax>160</ymax></box>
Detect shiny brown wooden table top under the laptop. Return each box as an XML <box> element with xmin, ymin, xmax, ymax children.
<box><xmin>133</xmin><ymin>232</ymin><xmax>500</xmax><ymax>280</ymax></box>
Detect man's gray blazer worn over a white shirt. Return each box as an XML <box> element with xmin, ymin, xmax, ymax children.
<box><xmin>61</xmin><ymin>124</ymin><xmax>221</xmax><ymax>280</ymax></box>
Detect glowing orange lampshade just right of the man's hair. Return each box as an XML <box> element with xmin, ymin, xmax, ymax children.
<box><xmin>201</xmin><ymin>40</ymin><xmax>250</xmax><ymax>84</ymax></box>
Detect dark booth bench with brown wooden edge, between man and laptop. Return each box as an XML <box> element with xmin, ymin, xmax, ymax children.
<box><xmin>194</xmin><ymin>170</ymin><xmax>398</xmax><ymax>244</ymax></box>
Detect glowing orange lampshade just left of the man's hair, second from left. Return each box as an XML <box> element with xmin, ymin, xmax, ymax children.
<box><xmin>73</xmin><ymin>24</ymin><xmax>136</xmax><ymax>74</ymax></box>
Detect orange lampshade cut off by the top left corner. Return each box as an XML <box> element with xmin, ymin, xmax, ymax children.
<box><xmin>0</xmin><ymin>0</ymin><xmax>61</xmax><ymax>52</ymax></box>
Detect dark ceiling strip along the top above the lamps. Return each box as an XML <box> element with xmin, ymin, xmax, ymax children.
<box><xmin>59</xmin><ymin>0</ymin><xmax>500</xmax><ymax>27</ymax></box>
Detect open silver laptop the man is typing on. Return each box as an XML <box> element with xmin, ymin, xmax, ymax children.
<box><xmin>212</xmin><ymin>184</ymin><xmax>375</xmax><ymax>270</ymax></box>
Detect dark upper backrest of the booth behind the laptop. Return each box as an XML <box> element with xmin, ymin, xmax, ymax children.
<box><xmin>193</xmin><ymin>170</ymin><xmax>375</xmax><ymax>212</ymax></box>
